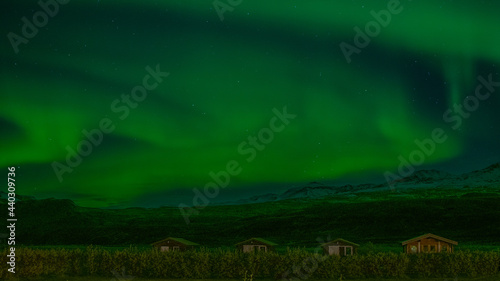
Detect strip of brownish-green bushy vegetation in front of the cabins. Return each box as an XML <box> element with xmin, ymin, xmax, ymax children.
<box><xmin>0</xmin><ymin>246</ymin><xmax>500</xmax><ymax>280</ymax></box>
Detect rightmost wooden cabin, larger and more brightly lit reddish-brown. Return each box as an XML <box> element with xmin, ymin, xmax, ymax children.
<box><xmin>401</xmin><ymin>233</ymin><xmax>458</xmax><ymax>254</ymax></box>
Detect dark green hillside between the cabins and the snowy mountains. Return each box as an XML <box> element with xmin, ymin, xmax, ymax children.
<box><xmin>0</xmin><ymin>188</ymin><xmax>500</xmax><ymax>247</ymax></box>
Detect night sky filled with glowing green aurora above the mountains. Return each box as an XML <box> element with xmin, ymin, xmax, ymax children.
<box><xmin>0</xmin><ymin>0</ymin><xmax>500</xmax><ymax>207</ymax></box>
